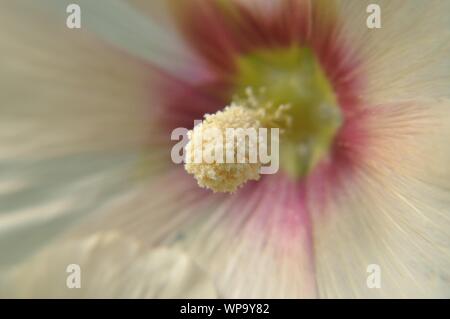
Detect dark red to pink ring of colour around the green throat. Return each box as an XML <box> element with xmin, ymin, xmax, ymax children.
<box><xmin>160</xmin><ymin>0</ymin><xmax>370</xmax><ymax>228</ymax></box>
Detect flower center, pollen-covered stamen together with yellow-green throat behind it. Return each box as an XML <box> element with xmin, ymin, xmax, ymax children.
<box><xmin>185</xmin><ymin>46</ymin><xmax>342</xmax><ymax>192</ymax></box>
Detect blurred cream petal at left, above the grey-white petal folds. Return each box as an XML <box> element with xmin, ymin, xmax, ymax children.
<box><xmin>0</xmin><ymin>3</ymin><xmax>154</xmax><ymax>159</ymax></box>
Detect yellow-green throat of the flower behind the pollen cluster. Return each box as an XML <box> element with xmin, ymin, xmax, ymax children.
<box><xmin>233</xmin><ymin>46</ymin><xmax>342</xmax><ymax>178</ymax></box>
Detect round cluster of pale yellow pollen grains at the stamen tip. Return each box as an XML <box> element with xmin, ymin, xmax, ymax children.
<box><xmin>184</xmin><ymin>104</ymin><xmax>261</xmax><ymax>193</ymax></box>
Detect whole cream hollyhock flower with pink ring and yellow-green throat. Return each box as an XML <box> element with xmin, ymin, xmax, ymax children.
<box><xmin>0</xmin><ymin>0</ymin><xmax>450</xmax><ymax>298</ymax></box>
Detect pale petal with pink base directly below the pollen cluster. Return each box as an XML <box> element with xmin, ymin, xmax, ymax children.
<box><xmin>59</xmin><ymin>173</ymin><xmax>316</xmax><ymax>298</ymax></box>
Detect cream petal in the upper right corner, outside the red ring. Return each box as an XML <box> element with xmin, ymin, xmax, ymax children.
<box><xmin>339</xmin><ymin>0</ymin><xmax>450</xmax><ymax>104</ymax></box>
